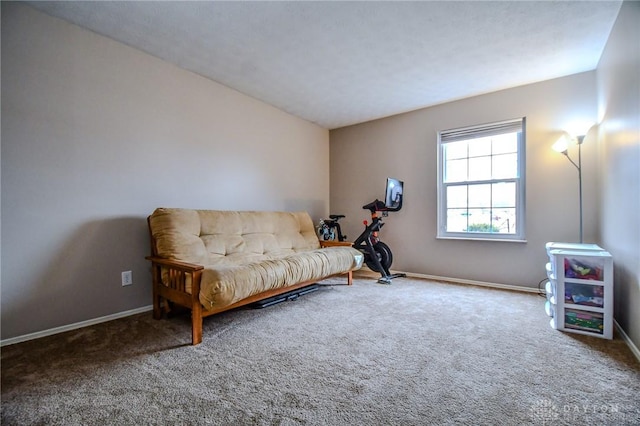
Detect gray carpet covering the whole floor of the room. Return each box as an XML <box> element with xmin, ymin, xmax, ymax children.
<box><xmin>1</xmin><ymin>278</ymin><xmax>640</xmax><ymax>425</ymax></box>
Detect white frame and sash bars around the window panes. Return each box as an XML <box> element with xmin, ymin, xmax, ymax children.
<box><xmin>437</xmin><ymin>117</ymin><xmax>526</xmax><ymax>242</ymax></box>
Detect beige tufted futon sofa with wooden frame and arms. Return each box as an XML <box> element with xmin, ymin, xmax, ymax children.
<box><xmin>147</xmin><ymin>208</ymin><xmax>363</xmax><ymax>345</ymax></box>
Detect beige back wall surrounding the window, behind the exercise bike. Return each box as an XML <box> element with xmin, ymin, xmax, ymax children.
<box><xmin>330</xmin><ymin>72</ymin><xmax>597</xmax><ymax>288</ymax></box>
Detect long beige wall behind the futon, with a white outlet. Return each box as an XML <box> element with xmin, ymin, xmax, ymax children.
<box><xmin>1</xmin><ymin>2</ymin><xmax>329</xmax><ymax>339</ymax></box>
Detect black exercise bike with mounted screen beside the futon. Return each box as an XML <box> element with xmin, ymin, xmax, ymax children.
<box><xmin>318</xmin><ymin>179</ymin><xmax>406</xmax><ymax>284</ymax></box>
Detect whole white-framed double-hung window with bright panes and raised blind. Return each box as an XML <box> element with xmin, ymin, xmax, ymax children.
<box><xmin>438</xmin><ymin>118</ymin><xmax>525</xmax><ymax>241</ymax></box>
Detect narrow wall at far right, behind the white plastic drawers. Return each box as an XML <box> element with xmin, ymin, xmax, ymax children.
<box><xmin>597</xmin><ymin>1</ymin><xmax>640</xmax><ymax>347</ymax></box>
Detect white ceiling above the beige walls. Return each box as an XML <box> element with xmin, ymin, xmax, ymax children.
<box><xmin>29</xmin><ymin>1</ymin><xmax>621</xmax><ymax>129</ymax></box>
